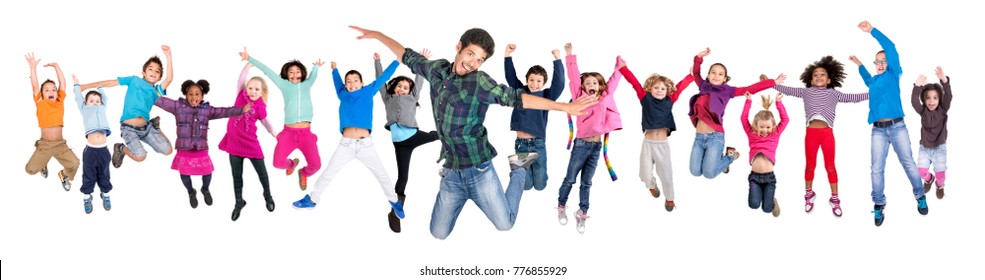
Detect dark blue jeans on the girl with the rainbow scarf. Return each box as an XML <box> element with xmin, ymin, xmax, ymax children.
<box><xmin>557</xmin><ymin>139</ymin><xmax>602</xmax><ymax>213</ymax></box>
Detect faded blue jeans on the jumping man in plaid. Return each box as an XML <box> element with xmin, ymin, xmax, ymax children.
<box><xmin>431</xmin><ymin>161</ymin><xmax>527</xmax><ymax>239</ymax></box>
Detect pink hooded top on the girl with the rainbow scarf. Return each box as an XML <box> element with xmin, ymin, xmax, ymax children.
<box><xmin>565</xmin><ymin>55</ymin><xmax>622</xmax><ymax>138</ymax></box>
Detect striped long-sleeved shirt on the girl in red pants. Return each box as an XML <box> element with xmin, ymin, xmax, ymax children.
<box><xmin>773</xmin><ymin>85</ymin><xmax>869</xmax><ymax>127</ymax></box>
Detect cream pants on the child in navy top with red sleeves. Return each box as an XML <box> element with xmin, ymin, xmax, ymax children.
<box><xmin>640</xmin><ymin>139</ymin><xmax>674</xmax><ymax>201</ymax></box>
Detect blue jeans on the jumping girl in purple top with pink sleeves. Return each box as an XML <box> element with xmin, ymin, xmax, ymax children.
<box><xmin>689</xmin><ymin>132</ymin><xmax>732</xmax><ymax>179</ymax></box>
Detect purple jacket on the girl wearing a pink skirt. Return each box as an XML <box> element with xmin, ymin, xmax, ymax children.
<box><xmin>154</xmin><ymin>97</ymin><xmax>243</xmax><ymax>151</ymax></box>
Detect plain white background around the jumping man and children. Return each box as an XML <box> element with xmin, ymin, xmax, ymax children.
<box><xmin>0</xmin><ymin>1</ymin><xmax>983</xmax><ymax>279</ymax></box>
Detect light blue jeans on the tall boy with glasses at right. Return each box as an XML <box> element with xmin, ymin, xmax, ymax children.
<box><xmin>872</xmin><ymin>122</ymin><xmax>923</xmax><ymax>205</ymax></box>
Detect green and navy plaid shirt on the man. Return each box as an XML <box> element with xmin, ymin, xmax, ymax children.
<box><xmin>403</xmin><ymin>48</ymin><xmax>523</xmax><ymax>169</ymax></box>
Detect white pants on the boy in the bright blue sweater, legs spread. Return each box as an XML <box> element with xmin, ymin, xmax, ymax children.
<box><xmin>311</xmin><ymin>137</ymin><xmax>397</xmax><ymax>203</ymax></box>
